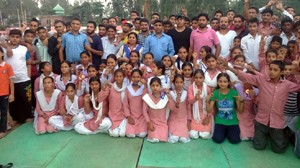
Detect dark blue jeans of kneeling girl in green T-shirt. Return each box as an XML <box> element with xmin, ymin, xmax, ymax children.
<box><xmin>212</xmin><ymin>124</ymin><xmax>241</xmax><ymax>144</ymax></box>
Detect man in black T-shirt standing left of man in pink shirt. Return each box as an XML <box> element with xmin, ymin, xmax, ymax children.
<box><xmin>168</xmin><ymin>15</ymin><xmax>192</xmax><ymax>54</ymax></box>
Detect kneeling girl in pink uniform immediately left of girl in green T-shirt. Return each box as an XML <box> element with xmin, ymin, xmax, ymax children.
<box><xmin>188</xmin><ymin>69</ymin><xmax>214</xmax><ymax>139</ymax></box>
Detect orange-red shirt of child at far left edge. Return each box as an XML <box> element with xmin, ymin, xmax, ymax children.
<box><xmin>0</xmin><ymin>61</ymin><xmax>15</xmax><ymax>96</ymax></box>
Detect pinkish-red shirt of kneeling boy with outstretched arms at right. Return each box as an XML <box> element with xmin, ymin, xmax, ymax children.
<box><xmin>237</xmin><ymin>71</ymin><xmax>300</xmax><ymax>129</ymax></box>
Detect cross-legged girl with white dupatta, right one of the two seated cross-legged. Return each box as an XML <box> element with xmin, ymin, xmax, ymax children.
<box><xmin>74</xmin><ymin>77</ymin><xmax>111</xmax><ymax>135</ymax></box>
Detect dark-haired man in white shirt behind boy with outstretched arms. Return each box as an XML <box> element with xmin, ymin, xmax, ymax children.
<box><xmin>241</xmin><ymin>18</ymin><xmax>261</xmax><ymax>70</ymax></box>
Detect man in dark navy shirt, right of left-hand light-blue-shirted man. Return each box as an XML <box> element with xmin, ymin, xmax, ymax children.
<box><xmin>86</xmin><ymin>21</ymin><xmax>103</xmax><ymax>69</ymax></box>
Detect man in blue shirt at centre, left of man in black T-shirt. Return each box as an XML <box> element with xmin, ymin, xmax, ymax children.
<box><xmin>143</xmin><ymin>19</ymin><xmax>175</xmax><ymax>61</ymax></box>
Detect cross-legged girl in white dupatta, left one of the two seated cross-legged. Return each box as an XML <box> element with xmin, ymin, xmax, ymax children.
<box><xmin>49</xmin><ymin>83</ymin><xmax>85</xmax><ymax>131</ymax></box>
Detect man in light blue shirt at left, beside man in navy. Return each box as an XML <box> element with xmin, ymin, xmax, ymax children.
<box><xmin>59</xmin><ymin>18</ymin><xmax>90</xmax><ymax>64</ymax></box>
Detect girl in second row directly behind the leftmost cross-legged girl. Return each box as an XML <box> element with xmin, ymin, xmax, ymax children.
<box><xmin>55</xmin><ymin>61</ymin><xmax>77</xmax><ymax>93</ymax></box>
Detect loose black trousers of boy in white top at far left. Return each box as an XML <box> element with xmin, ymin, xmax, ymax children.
<box><xmin>9</xmin><ymin>80</ymin><xmax>33</xmax><ymax>123</ymax></box>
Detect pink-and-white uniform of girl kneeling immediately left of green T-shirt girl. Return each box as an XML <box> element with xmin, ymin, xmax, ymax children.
<box><xmin>188</xmin><ymin>83</ymin><xmax>214</xmax><ymax>139</ymax></box>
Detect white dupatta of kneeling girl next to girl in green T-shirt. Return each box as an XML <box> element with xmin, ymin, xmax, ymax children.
<box><xmin>193</xmin><ymin>82</ymin><xmax>207</xmax><ymax>123</ymax></box>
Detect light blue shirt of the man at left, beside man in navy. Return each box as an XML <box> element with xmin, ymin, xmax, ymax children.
<box><xmin>62</xmin><ymin>32</ymin><xmax>89</xmax><ymax>62</ymax></box>
